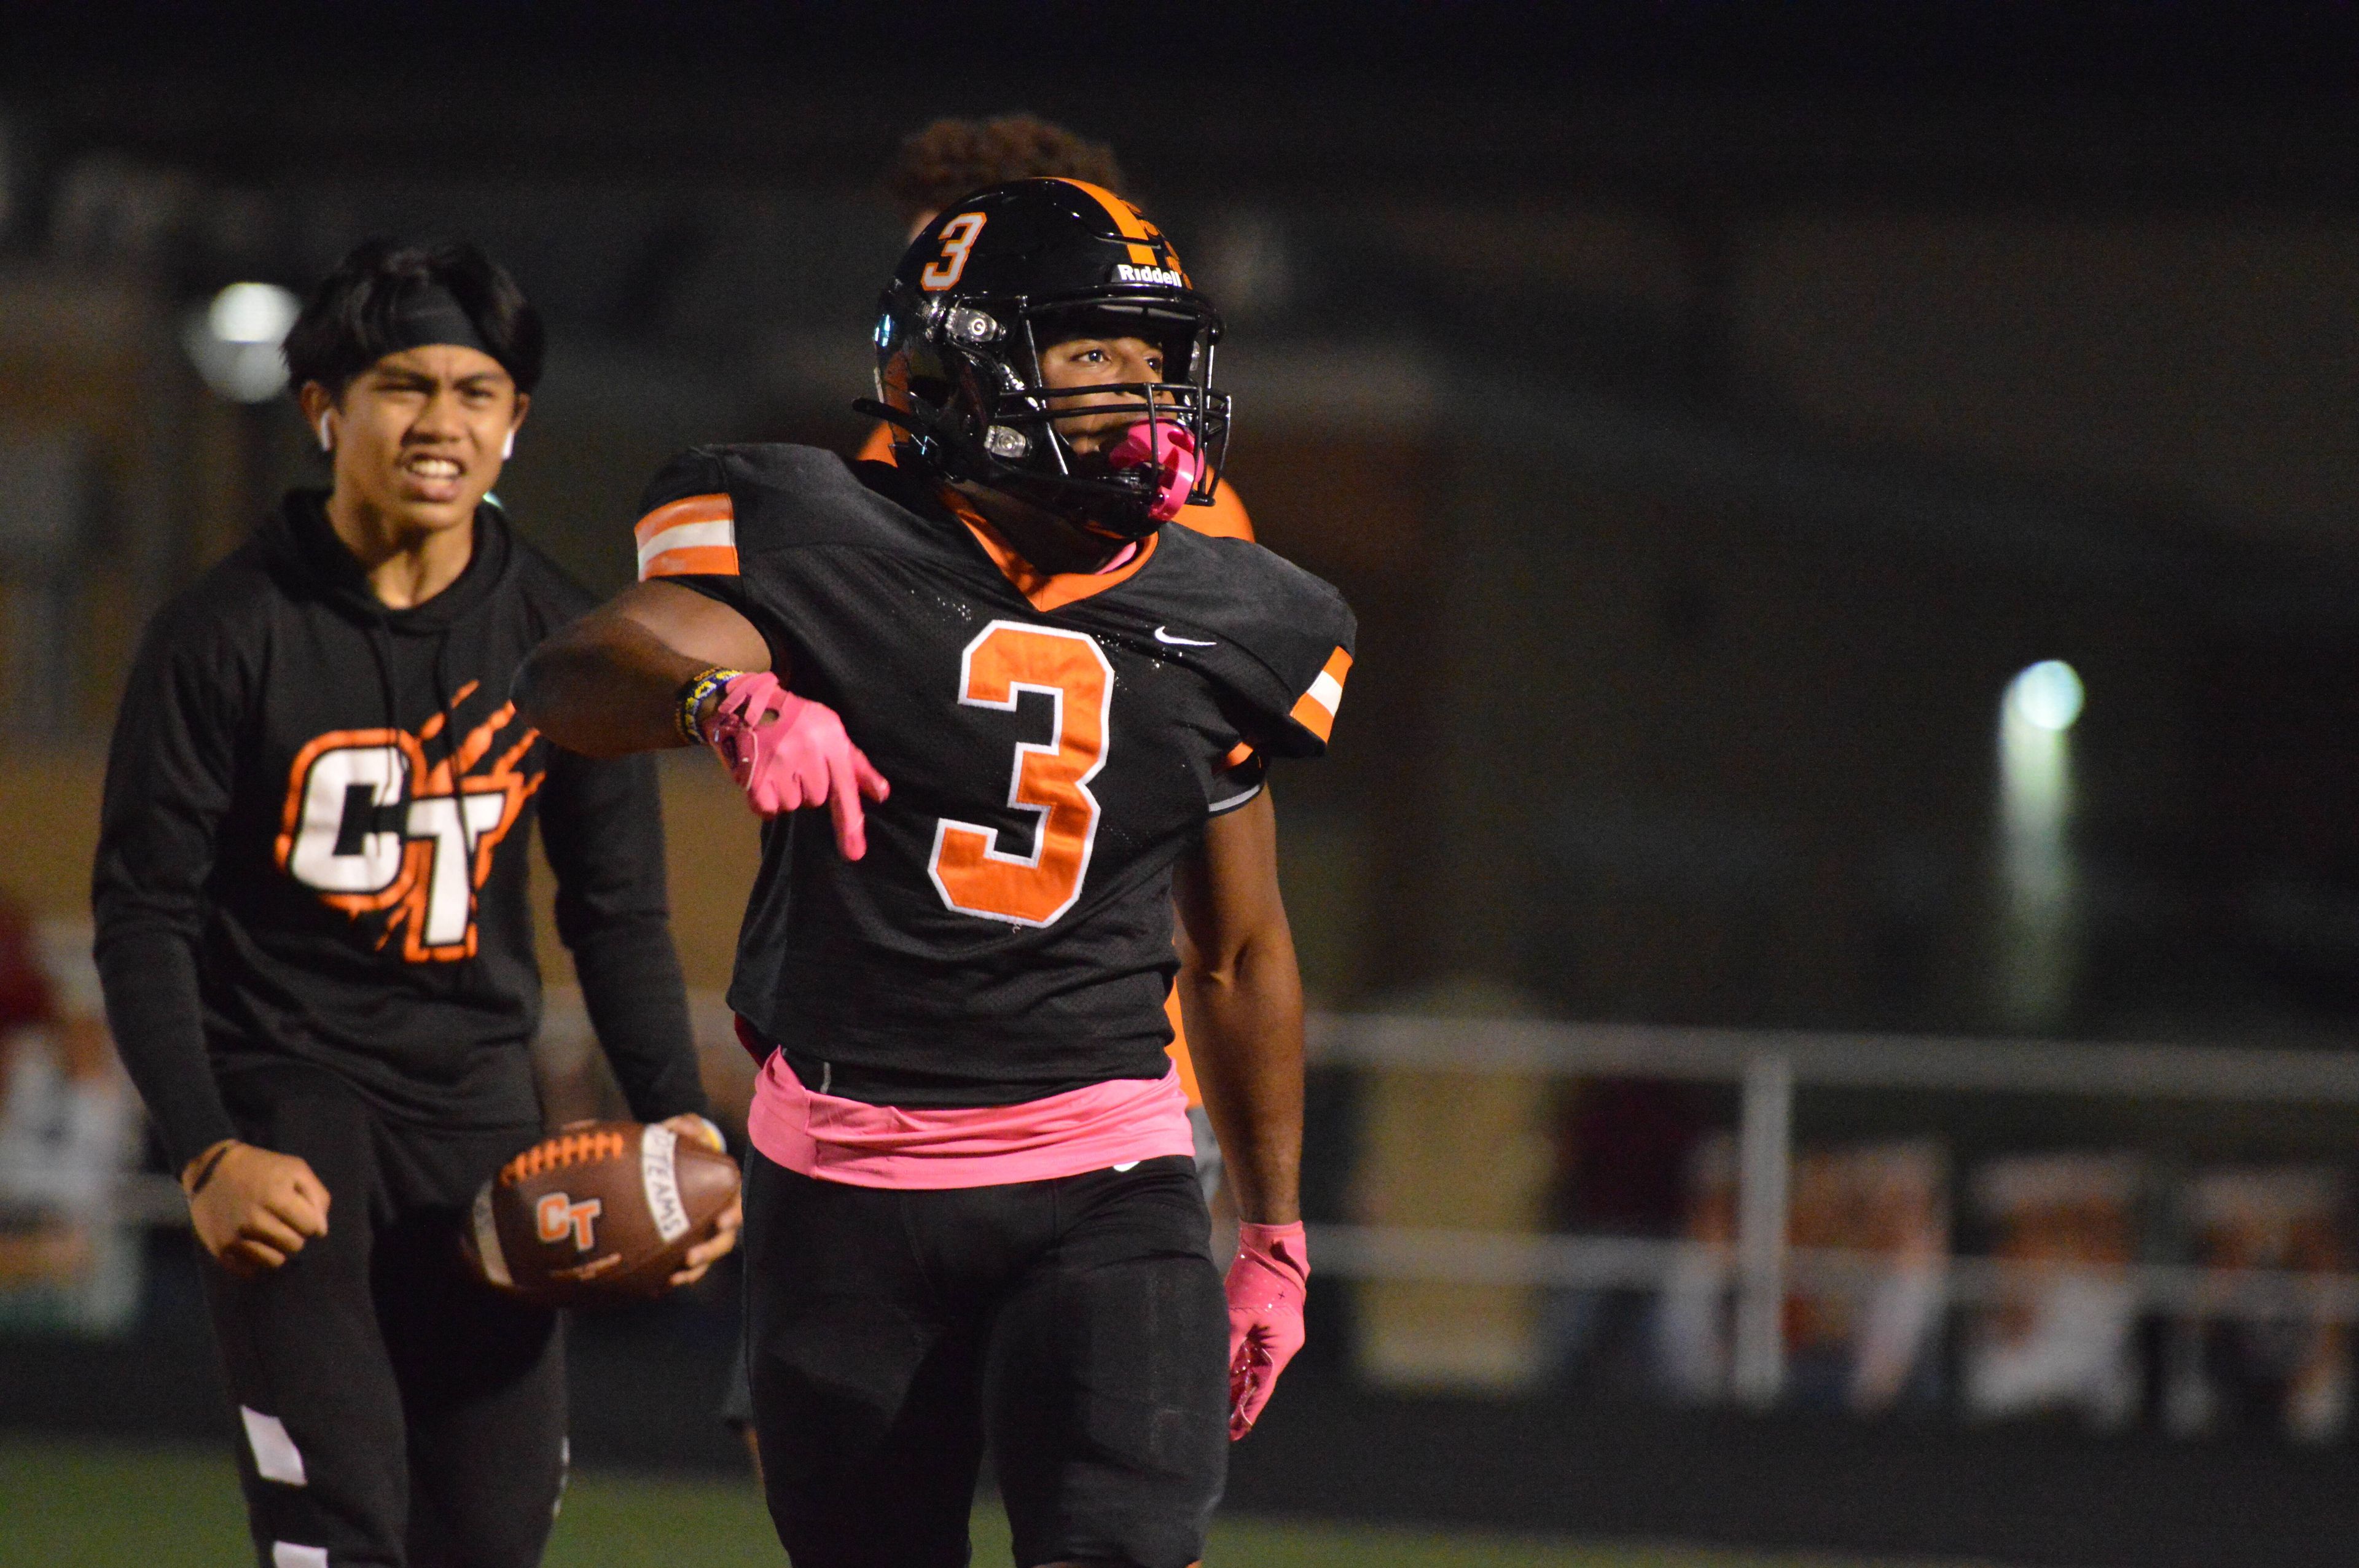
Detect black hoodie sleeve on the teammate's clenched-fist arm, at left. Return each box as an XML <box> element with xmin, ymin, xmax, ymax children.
<box><xmin>92</xmin><ymin>610</ymin><xmax>243</xmax><ymax>1172</ymax></box>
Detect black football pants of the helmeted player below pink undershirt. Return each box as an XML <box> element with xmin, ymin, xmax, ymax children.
<box><xmin>745</xmin><ymin>1153</ymin><xmax>1229</xmax><ymax>1568</ymax></box>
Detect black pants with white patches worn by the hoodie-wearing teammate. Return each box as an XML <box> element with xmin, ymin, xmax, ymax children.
<box><xmin>200</xmin><ymin>1066</ymin><xmax>566</xmax><ymax>1568</ymax></box>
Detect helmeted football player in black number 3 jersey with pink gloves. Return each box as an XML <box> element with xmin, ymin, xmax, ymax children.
<box><xmin>517</xmin><ymin>179</ymin><xmax>1354</xmax><ymax>1568</ymax></box>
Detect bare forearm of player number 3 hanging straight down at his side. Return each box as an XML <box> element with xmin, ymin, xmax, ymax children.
<box><xmin>1172</xmin><ymin>790</ymin><xmax>1302</xmax><ymax>1226</ymax></box>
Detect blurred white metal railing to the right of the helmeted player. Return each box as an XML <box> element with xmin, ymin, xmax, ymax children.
<box><xmin>1309</xmin><ymin>1014</ymin><xmax>2359</xmax><ymax>1405</ymax></box>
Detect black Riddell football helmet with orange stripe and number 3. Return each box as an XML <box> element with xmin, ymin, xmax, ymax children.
<box><xmin>861</xmin><ymin>179</ymin><xmax>1229</xmax><ymax>537</ymax></box>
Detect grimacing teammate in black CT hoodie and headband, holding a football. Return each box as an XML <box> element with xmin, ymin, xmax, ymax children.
<box><xmin>95</xmin><ymin>241</ymin><xmax>734</xmax><ymax>1568</ymax></box>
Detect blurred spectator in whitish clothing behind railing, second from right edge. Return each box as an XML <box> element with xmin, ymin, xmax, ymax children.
<box><xmin>1963</xmin><ymin>1153</ymin><xmax>2142</xmax><ymax>1429</ymax></box>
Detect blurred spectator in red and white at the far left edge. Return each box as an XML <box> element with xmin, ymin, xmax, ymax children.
<box><xmin>0</xmin><ymin>896</ymin><xmax>139</xmax><ymax>1332</ymax></box>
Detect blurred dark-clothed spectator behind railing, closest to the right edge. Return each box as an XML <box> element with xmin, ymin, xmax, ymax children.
<box><xmin>2170</xmin><ymin>1165</ymin><xmax>2352</xmax><ymax>1443</ymax></box>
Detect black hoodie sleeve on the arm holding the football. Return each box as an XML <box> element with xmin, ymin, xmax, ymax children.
<box><xmin>540</xmin><ymin>750</ymin><xmax>708</xmax><ymax>1122</ymax></box>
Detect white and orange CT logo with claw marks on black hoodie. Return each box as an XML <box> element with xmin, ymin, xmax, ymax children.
<box><xmin>278</xmin><ymin>681</ymin><xmax>542</xmax><ymax>964</ymax></box>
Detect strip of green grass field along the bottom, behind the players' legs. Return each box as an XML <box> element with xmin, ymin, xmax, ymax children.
<box><xmin>0</xmin><ymin>1438</ymin><xmax>1981</xmax><ymax>1568</ymax></box>
